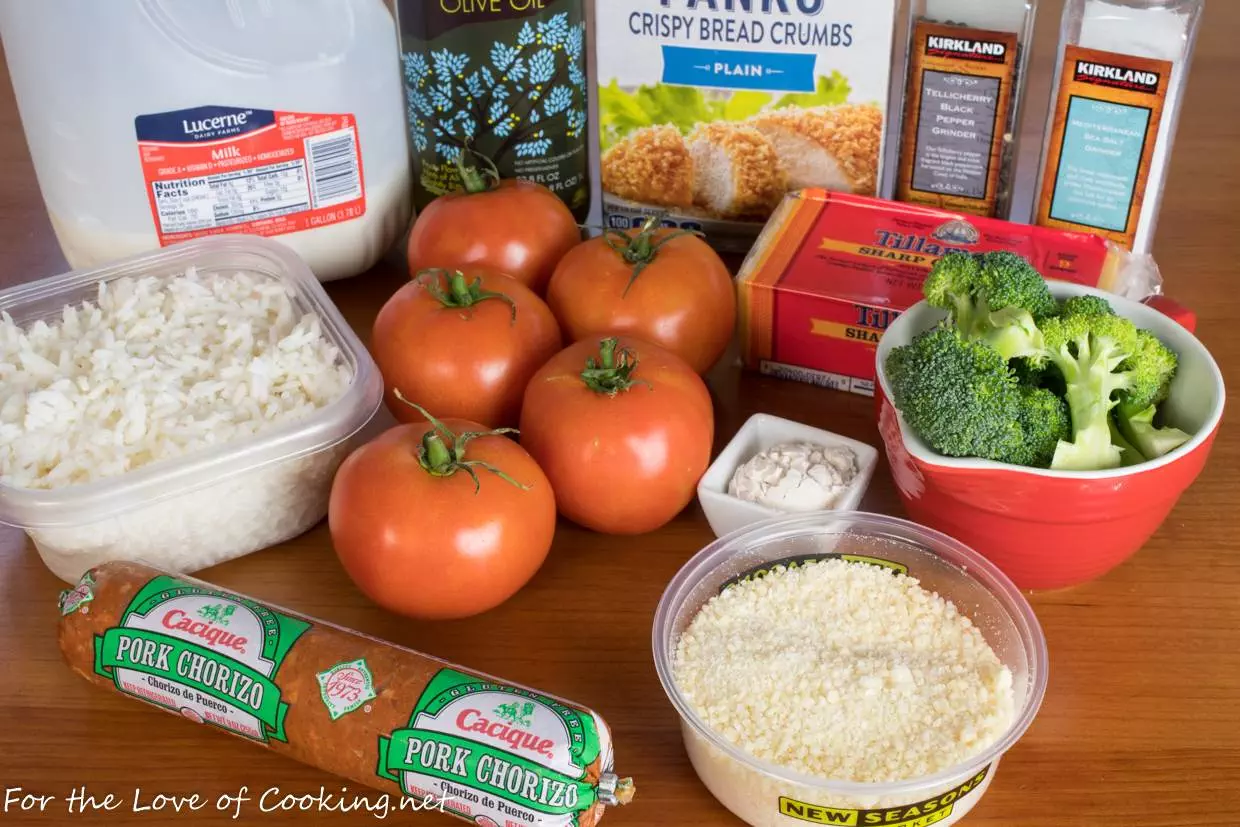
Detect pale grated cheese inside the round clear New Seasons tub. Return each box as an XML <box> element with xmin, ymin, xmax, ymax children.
<box><xmin>672</xmin><ymin>559</ymin><xmax>1014</xmax><ymax>784</ymax></box>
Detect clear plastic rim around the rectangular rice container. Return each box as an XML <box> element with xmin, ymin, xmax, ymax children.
<box><xmin>0</xmin><ymin>234</ymin><xmax>383</xmax><ymax>528</ymax></box>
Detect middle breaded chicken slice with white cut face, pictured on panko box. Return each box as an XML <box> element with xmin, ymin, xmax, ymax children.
<box><xmin>688</xmin><ymin>122</ymin><xmax>787</xmax><ymax>218</ymax></box>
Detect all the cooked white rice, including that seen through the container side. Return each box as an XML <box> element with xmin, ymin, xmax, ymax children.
<box><xmin>0</xmin><ymin>268</ymin><xmax>361</xmax><ymax>582</ymax></box>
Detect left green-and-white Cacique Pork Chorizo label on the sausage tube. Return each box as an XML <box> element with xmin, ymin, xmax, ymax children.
<box><xmin>94</xmin><ymin>577</ymin><xmax>310</xmax><ymax>743</ymax></box>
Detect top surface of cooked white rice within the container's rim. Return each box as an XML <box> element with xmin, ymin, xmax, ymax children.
<box><xmin>0</xmin><ymin>269</ymin><xmax>352</xmax><ymax>489</ymax></box>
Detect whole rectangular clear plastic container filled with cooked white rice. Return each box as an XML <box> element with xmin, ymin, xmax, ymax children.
<box><xmin>0</xmin><ymin>236</ymin><xmax>382</xmax><ymax>583</ymax></box>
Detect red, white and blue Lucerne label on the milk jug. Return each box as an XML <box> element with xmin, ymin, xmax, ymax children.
<box><xmin>138</xmin><ymin>107</ymin><xmax>366</xmax><ymax>244</ymax></box>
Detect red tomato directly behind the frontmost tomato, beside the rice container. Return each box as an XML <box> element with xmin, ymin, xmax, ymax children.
<box><xmin>371</xmin><ymin>267</ymin><xmax>560</xmax><ymax>428</ymax></box>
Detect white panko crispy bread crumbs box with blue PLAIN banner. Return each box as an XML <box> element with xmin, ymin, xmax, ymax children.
<box><xmin>594</xmin><ymin>0</ymin><xmax>901</xmax><ymax>252</ymax></box>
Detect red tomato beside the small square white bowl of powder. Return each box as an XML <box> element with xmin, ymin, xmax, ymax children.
<box><xmin>521</xmin><ymin>337</ymin><xmax>714</xmax><ymax>534</ymax></box>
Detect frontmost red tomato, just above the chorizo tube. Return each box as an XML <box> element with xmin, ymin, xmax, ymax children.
<box><xmin>327</xmin><ymin>419</ymin><xmax>556</xmax><ymax>620</ymax></box>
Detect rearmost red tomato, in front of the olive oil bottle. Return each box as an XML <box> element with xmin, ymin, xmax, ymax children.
<box><xmin>409</xmin><ymin>179</ymin><xmax>582</xmax><ymax>294</ymax></box>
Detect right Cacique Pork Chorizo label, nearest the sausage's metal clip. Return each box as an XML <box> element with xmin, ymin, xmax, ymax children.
<box><xmin>377</xmin><ymin>670</ymin><xmax>601</xmax><ymax>827</ymax></box>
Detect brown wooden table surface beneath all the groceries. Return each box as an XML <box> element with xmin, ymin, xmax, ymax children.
<box><xmin>0</xmin><ymin>0</ymin><xmax>1240</xmax><ymax>827</ymax></box>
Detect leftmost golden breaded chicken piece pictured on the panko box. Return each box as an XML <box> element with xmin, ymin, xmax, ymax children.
<box><xmin>601</xmin><ymin>126</ymin><xmax>693</xmax><ymax>207</ymax></box>
